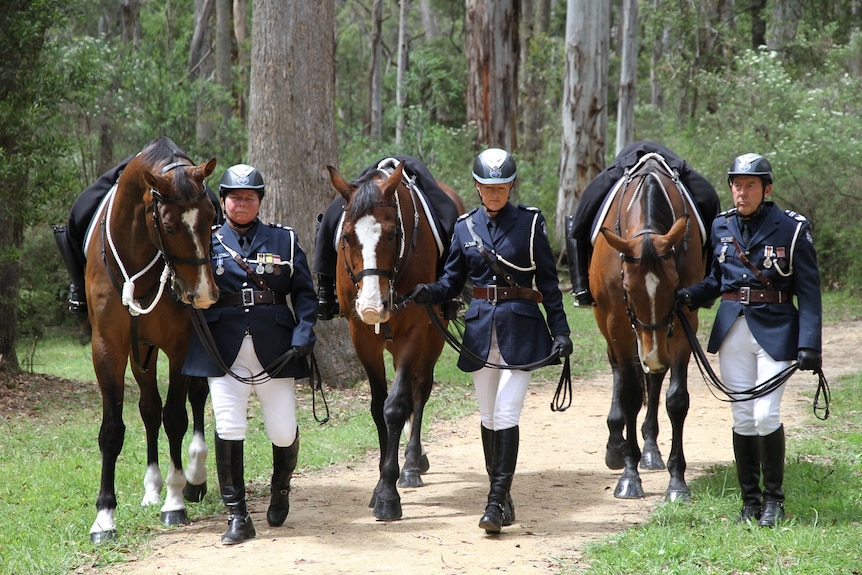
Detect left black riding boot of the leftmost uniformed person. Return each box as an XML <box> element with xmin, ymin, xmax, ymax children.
<box><xmin>215</xmin><ymin>434</ymin><xmax>256</xmax><ymax>545</ymax></box>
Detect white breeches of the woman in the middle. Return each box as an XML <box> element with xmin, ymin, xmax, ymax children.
<box><xmin>473</xmin><ymin>328</ymin><xmax>530</xmax><ymax>431</ymax></box>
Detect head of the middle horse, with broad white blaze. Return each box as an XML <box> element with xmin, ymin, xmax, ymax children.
<box><xmin>327</xmin><ymin>163</ymin><xmax>404</xmax><ymax>325</ymax></box>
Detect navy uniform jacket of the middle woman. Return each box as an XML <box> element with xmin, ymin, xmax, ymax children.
<box><xmin>429</xmin><ymin>204</ymin><xmax>569</xmax><ymax>372</ymax></box>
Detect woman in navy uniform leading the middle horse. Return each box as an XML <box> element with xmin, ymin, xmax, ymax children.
<box><xmin>411</xmin><ymin>148</ymin><xmax>572</xmax><ymax>533</ymax></box>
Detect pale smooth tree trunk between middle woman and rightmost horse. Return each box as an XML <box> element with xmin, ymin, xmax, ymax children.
<box><xmin>554</xmin><ymin>0</ymin><xmax>610</xmax><ymax>240</ymax></box>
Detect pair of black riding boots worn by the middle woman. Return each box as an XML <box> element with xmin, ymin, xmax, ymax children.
<box><xmin>479</xmin><ymin>425</ymin><xmax>520</xmax><ymax>533</ymax></box>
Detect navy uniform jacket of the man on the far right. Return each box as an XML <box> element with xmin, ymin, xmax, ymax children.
<box><xmin>689</xmin><ymin>202</ymin><xmax>822</xmax><ymax>361</ymax></box>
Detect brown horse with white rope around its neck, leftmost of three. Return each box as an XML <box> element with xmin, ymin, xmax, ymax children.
<box><xmin>85</xmin><ymin>137</ymin><xmax>218</xmax><ymax>543</ymax></box>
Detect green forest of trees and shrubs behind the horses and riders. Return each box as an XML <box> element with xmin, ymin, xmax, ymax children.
<box><xmin>0</xmin><ymin>0</ymin><xmax>862</xmax><ymax>383</ymax></box>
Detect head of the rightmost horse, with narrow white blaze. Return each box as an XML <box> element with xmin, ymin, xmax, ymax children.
<box><xmin>601</xmin><ymin>216</ymin><xmax>688</xmax><ymax>373</ymax></box>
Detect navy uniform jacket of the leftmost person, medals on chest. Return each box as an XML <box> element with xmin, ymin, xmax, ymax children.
<box><xmin>183</xmin><ymin>222</ymin><xmax>317</xmax><ymax>378</ymax></box>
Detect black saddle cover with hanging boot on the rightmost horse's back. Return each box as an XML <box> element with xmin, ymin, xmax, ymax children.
<box><xmin>566</xmin><ymin>141</ymin><xmax>721</xmax><ymax>307</ymax></box>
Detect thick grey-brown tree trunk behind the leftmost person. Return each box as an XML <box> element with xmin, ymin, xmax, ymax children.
<box><xmin>248</xmin><ymin>0</ymin><xmax>364</xmax><ymax>392</ymax></box>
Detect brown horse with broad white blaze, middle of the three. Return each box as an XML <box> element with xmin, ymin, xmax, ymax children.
<box><xmin>327</xmin><ymin>162</ymin><xmax>464</xmax><ymax>521</ymax></box>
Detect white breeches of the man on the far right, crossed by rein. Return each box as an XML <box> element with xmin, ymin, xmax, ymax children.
<box><xmin>718</xmin><ymin>316</ymin><xmax>792</xmax><ymax>436</ymax></box>
